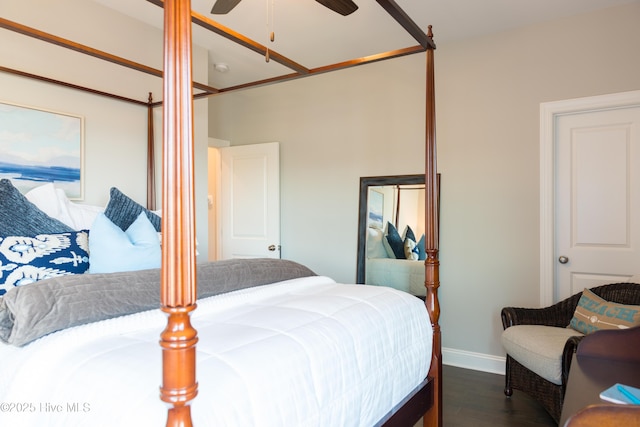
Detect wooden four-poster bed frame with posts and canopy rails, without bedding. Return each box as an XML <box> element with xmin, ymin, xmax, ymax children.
<box><xmin>0</xmin><ymin>0</ymin><xmax>442</xmax><ymax>426</ymax></box>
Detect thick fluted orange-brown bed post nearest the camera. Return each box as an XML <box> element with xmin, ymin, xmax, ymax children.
<box><xmin>160</xmin><ymin>0</ymin><xmax>198</xmax><ymax>427</ymax></box>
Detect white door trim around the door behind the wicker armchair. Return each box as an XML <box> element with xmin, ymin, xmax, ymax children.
<box><xmin>540</xmin><ymin>90</ymin><xmax>640</xmax><ymax>307</ymax></box>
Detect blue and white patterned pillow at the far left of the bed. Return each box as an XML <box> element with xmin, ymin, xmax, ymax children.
<box><xmin>0</xmin><ymin>230</ymin><xmax>89</xmax><ymax>296</ymax></box>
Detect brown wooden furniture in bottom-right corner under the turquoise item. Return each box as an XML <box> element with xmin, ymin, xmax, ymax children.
<box><xmin>559</xmin><ymin>327</ymin><xmax>640</xmax><ymax>427</ymax></box>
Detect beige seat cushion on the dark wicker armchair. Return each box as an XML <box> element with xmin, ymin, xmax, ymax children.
<box><xmin>502</xmin><ymin>325</ymin><xmax>582</xmax><ymax>385</ymax></box>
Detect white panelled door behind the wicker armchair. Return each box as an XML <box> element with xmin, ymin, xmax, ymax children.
<box><xmin>554</xmin><ymin>105</ymin><xmax>640</xmax><ymax>301</ymax></box>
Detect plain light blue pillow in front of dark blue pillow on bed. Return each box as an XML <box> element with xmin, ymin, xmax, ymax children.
<box><xmin>89</xmin><ymin>212</ymin><xmax>161</xmax><ymax>273</ymax></box>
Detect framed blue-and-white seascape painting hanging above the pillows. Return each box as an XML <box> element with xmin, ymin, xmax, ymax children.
<box><xmin>0</xmin><ymin>102</ymin><xmax>84</xmax><ymax>200</ymax></box>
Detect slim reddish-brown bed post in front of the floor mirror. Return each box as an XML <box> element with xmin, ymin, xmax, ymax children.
<box><xmin>423</xmin><ymin>25</ymin><xmax>442</xmax><ymax>427</ymax></box>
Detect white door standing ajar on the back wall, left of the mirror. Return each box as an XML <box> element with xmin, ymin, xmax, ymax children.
<box><xmin>220</xmin><ymin>142</ymin><xmax>280</xmax><ymax>259</ymax></box>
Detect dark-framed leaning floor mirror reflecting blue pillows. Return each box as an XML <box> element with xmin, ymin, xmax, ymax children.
<box><xmin>356</xmin><ymin>174</ymin><xmax>440</xmax><ymax>297</ymax></box>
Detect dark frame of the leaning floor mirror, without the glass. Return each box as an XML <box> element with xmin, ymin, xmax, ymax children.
<box><xmin>356</xmin><ymin>174</ymin><xmax>425</xmax><ymax>284</ymax></box>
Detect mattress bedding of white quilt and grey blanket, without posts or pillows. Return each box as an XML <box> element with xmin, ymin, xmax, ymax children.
<box><xmin>0</xmin><ymin>259</ymin><xmax>431</xmax><ymax>427</ymax></box>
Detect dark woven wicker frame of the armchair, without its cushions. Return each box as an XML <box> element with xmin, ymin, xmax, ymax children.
<box><xmin>501</xmin><ymin>283</ymin><xmax>640</xmax><ymax>421</ymax></box>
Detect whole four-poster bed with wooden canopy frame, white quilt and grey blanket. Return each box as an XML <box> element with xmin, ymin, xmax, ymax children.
<box><xmin>0</xmin><ymin>0</ymin><xmax>442</xmax><ymax>426</ymax></box>
